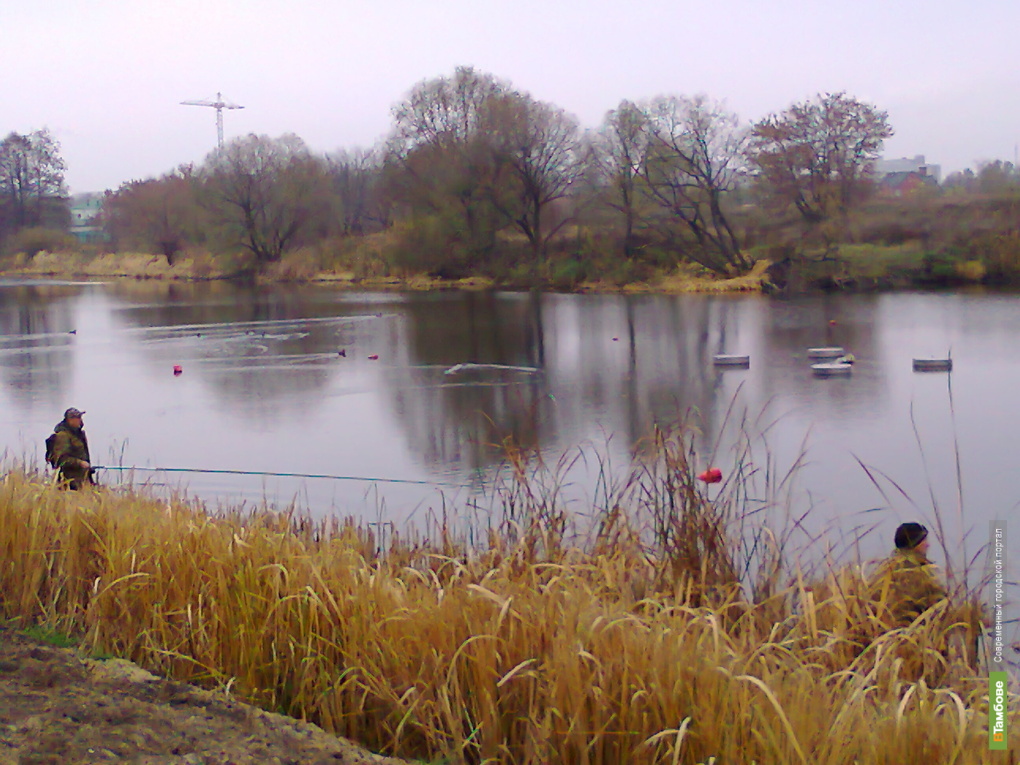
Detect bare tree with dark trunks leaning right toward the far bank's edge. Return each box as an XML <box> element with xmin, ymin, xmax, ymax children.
<box><xmin>644</xmin><ymin>96</ymin><xmax>752</xmax><ymax>274</ymax></box>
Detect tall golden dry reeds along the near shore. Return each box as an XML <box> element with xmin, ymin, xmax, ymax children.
<box><xmin>0</xmin><ymin>431</ymin><xmax>1007</xmax><ymax>765</ymax></box>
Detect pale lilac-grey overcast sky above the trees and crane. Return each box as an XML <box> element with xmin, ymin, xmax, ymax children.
<box><xmin>0</xmin><ymin>0</ymin><xmax>1020</xmax><ymax>192</ymax></box>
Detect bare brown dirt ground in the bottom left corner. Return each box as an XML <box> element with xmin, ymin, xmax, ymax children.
<box><xmin>0</xmin><ymin>627</ymin><xmax>414</xmax><ymax>765</ymax></box>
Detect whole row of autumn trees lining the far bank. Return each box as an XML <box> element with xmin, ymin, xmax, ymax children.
<box><xmin>7</xmin><ymin>67</ymin><xmax>1016</xmax><ymax>282</ymax></box>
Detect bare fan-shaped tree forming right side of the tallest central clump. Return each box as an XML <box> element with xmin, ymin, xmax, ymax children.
<box><xmin>492</xmin><ymin>93</ymin><xmax>583</xmax><ymax>262</ymax></box>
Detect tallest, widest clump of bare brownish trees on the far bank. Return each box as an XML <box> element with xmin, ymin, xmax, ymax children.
<box><xmin>389</xmin><ymin>66</ymin><xmax>579</xmax><ymax>274</ymax></box>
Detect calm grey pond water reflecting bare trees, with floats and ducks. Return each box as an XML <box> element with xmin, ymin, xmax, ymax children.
<box><xmin>0</xmin><ymin>282</ymin><xmax>1020</xmax><ymax>575</ymax></box>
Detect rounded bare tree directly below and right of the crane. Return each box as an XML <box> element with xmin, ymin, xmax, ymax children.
<box><xmin>205</xmin><ymin>135</ymin><xmax>328</xmax><ymax>264</ymax></box>
